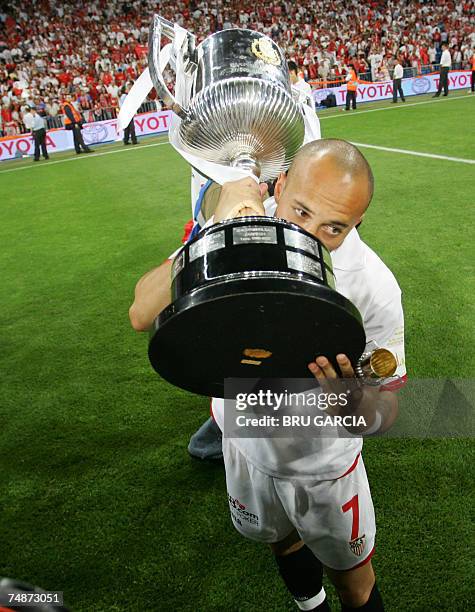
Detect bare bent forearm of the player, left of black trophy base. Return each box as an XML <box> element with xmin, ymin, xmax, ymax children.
<box><xmin>129</xmin><ymin>259</ymin><xmax>173</xmax><ymax>331</ymax></box>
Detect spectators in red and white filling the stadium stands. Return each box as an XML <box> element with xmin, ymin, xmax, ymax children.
<box><xmin>0</xmin><ymin>0</ymin><xmax>475</xmax><ymax>136</ymax></box>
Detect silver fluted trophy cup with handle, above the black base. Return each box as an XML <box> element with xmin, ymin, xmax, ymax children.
<box><xmin>149</xmin><ymin>15</ymin><xmax>305</xmax><ymax>181</ymax></box>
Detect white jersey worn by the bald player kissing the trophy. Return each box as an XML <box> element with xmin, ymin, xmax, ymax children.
<box><xmin>210</xmin><ymin>198</ymin><xmax>406</xmax><ymax>480</ymax></box>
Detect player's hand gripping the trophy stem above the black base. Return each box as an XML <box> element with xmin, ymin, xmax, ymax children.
<box><xmin>214</xmin><ymin>178</ymin><xmax>267</xmax><ymax>223</ymax></box>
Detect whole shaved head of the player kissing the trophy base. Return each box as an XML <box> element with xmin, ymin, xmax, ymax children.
<box><xmin>274</xmin><ymin>139</ymin><xmax>374</xmax><ymax>251</ymax></box>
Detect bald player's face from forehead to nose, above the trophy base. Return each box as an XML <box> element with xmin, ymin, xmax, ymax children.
<box><xmin>275</xmin><ymin>159</ymin><xmax>368</xmax><ymax>251</ymax></box>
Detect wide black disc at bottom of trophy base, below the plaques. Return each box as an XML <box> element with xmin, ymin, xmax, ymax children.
<box><xmin>148</xmin><ymin>276</ymin><xmax>365</xmax><ymax>397</ymax></box>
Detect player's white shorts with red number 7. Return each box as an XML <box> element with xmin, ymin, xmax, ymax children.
<box><xmin>223</xmin><ymin>438</ymin><xmax>376</xmax><ymax>570</ymax></box>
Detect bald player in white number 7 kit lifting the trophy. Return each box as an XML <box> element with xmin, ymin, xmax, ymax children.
<box><xmin>129</xmin><ymin>140</ymin><xmax>405</xmax><ymax>612</ymax></box>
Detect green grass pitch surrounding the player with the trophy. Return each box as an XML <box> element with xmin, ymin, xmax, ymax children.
<box><xmin>0</xmin><ymin>96</ymin><xmax>475</xmax><ymax>612</ymax></box>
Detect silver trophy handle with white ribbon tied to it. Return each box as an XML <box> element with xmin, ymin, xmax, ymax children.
<box><xmin>148</xmin><ymin>15</ymin><xmax>195</xmax><ymax>119</ymax></box>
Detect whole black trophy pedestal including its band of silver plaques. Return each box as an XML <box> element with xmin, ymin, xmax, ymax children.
<box><xmin>148</xmin><ymin>217</ymin><xmax>365</xmax><ymax>397</ymax></box>
